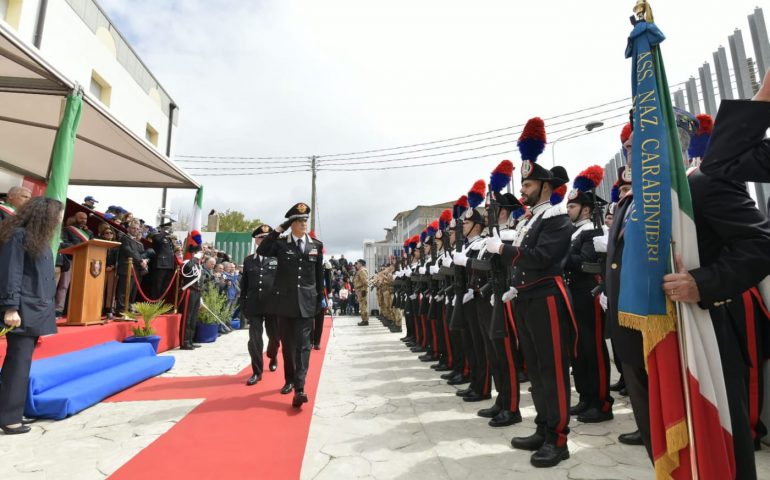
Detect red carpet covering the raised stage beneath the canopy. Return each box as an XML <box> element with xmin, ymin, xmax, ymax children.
<box><xmin>0</xmin><ymin>314</ymin><xmax>182</xmax><ymax>365</ymax></box>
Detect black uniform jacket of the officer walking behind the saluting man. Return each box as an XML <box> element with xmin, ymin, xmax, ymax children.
<box><xmin>241</xmin><ymin>254</ymin><xmax>278</xmax><ymax>317</ymax></box>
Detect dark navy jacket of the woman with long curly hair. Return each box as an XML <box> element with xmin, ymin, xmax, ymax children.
<box><xmin>0</xmin><ymin>228</ymin><xmax>56</xmax><ymax>337</ymax></box>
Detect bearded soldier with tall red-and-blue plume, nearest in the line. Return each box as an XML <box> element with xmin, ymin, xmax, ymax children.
<box><xmin>486</xmin><ymin>118</ymin><xmax>574</xmax><ymax>467</ymax></box>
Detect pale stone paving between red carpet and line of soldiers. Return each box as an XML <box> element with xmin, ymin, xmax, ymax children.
<box><xmin>302</xmin><ymin>317</ymin><xmax>770</xmax><ymax>480</ymax></box>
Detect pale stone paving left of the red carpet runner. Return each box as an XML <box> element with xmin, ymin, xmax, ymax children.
<box><xmin>0</xmin><ymin>330</ymin><xmax>250</xmax><ymax>480</ymax></box>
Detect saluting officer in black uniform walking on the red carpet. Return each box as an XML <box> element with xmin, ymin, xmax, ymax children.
<box><xmin>257</xmin><ymin>202</ymin><xmax>323</xmax><ymax>408</ymax></box>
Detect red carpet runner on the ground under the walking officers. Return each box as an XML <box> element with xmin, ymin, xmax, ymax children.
<box><xmin>106</xmin><ymin>317</ymin><xmax>331</xmax><ymax>480</ymax></box>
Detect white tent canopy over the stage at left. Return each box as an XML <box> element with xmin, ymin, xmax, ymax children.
<box><xmin>0</xmin><ymin>21</ymin><xmax>198</xmax><ymax>188</ymax></box>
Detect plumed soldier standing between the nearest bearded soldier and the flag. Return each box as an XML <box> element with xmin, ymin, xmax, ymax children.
<box><xmin>564</xmin><ymin>165</ymin><xmax>613</xmax><ymax>423</ymax></box>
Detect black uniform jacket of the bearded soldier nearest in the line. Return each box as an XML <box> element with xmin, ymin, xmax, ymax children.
<box><xmin>502</xmin><ymin>201</ymin><xmax>574</xmax><ymax>298</ymax></box>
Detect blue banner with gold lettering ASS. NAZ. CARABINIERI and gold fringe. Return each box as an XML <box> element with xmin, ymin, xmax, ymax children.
<box><xmin>618</xmin><ymin>22</ymin><xmax>672</xmax><ymax>330</ymax></box>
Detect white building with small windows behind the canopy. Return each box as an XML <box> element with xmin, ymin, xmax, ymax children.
<box><xmin>0</xmin><ymin>0</ymin><xmax>190</xmax><ymax>220</ymax></box>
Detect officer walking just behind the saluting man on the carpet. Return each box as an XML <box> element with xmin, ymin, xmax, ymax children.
<box><xmin>240</xmin><ymin>224</ymin><xmax>280</xmax><ymax>386</ymax></box>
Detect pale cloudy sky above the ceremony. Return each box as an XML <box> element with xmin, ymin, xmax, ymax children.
<box><xmin>77</xmin><ymin>0</ymin><xmax>770</xmax><ymax>257</ymax></box>
